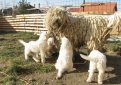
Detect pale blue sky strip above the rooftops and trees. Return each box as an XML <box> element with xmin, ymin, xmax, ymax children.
<box><xmin>0</xmin><ymin>0</ymin><xmax>121</xmax><ymax>10</ymax></box>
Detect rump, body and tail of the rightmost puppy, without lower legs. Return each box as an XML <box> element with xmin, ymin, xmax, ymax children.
<box><xmin>80</xmin><ymin>50</ymin><xmax>107</xmax><ymax>72</ymax></box>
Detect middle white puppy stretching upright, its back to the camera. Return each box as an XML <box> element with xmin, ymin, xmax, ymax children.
<box><xmin>55</xmin><ymin>37</ymin><xmax>73</xmax><ymax>79</ymax></box>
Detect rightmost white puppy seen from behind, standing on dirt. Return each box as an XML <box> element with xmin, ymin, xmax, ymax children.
<box><xmin>80</xmin><ymin>50</ymin><xmax>107</xmax><ymax>84</ymax></box>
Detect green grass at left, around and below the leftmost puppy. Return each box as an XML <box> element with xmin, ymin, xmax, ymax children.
<box><xmin>0</xmin><ymin>32</ymin><xmax>53</xmax><ymax>85</ymax></box>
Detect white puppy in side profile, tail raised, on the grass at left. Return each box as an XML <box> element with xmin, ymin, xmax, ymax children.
<box><xmin>19</xmin><ymin>32</ymin><xmax>48</xmax><ymax>63</ymax></box>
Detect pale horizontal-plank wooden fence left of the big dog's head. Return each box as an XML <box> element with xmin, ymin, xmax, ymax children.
<box><xmin>0</xmin><ymin>14</ymin><xmax>47</xmax><ymax>32</ymax></box>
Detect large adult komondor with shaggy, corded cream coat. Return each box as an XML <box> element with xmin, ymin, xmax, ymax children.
<box><xmin>45</xmin><ymin>7</ymin><xmax>121</xmax><ymax>50</ymax></box>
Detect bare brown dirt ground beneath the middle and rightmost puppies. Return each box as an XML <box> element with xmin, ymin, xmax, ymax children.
<box><xmin>18</xmin><ymin>53</ymin><xmax>121</xmax><ymax>85</ymax></box>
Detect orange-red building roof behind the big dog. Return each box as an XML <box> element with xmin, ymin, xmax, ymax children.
<box><xmin>68</xmin><ymin>2</ymin><xmax>117</xmax><ymax>12</ymax></box>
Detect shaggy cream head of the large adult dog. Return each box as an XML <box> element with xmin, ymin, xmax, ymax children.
<box><xmin>46</xmin><ymin>7</ymin><xmax>67</xmax><ymax>29</ymax></box>
